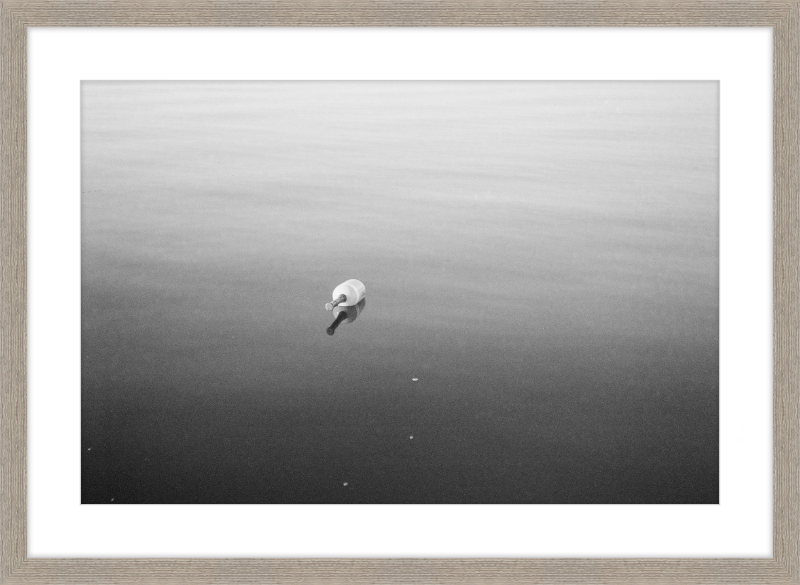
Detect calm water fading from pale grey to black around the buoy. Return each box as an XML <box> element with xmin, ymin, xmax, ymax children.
<box><xmin>81</xmin><ymin>82</ymin><xmax>719</xmax><ymax>504</ymax></box>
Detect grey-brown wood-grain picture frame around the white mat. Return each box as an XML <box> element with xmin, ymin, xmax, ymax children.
<box><xmin>0</xmin><ymin>1</ymin><xmax>800</xmax><ymax>583</ymax></box>
